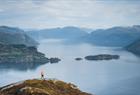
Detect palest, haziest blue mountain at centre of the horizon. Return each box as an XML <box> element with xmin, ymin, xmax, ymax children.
<box><xmin>27</xmin><ymin>26</ymin><xmax>88</xmax><ymax>39</ymax></box>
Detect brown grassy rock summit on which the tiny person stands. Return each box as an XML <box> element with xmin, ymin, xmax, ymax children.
<box><xmin>0</xmin><ymin>79</ymin><xmax>92</xmax><ymax>95</ymax></box>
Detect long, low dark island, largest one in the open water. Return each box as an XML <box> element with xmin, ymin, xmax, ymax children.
<box><xmin>85</xmin><ymin>54</ymin><xmax>120</xmax><ymax>60</ymax></box>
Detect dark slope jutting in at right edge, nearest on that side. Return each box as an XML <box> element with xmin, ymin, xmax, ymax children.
<box><xmin>125</xmin><ymin>40</ymin><xmax>140</xmax><ymax>56</ymax></box>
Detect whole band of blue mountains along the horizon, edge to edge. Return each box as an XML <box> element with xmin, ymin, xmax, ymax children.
<box><xmin>0</xmin><ymin>25</ymin><xmax>140</xmax><ymax>55</ymax></box>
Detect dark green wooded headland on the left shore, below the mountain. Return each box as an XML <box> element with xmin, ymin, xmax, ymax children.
<box><xmin>0</xmin><ymin>44</ymin><xmax>49</xmax><ymax>64</ymax></box>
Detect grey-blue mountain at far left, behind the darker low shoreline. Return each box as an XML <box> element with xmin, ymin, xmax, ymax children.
<box><xmin>0</xmin><ymin>26</ymin><xmax>38</xmax><ymax>46</ymax></box>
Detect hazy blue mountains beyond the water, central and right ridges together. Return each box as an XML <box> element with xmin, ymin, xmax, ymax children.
<box><xmin>27</xmin><ymin>25</ymin><xmax>140</xmax><ymax>47</ymax></box>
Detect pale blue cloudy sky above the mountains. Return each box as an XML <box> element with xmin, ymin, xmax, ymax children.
<box><xmin>0</xmin><ymin>0</ymin><xmax>140</xmax><ymax>29</ymax></box>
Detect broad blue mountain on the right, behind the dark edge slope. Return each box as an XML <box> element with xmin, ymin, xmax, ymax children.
<box><xmin>82</xmin><ymin>25</ymin><xmax>140</xmax><ymax>47</ymax></box>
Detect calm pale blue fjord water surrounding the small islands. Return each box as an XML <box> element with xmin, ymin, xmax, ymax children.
<box><xmin>0</xmin><ymin>40</ymin><xmax>140</xmax><ymax>95</ymax></box>
